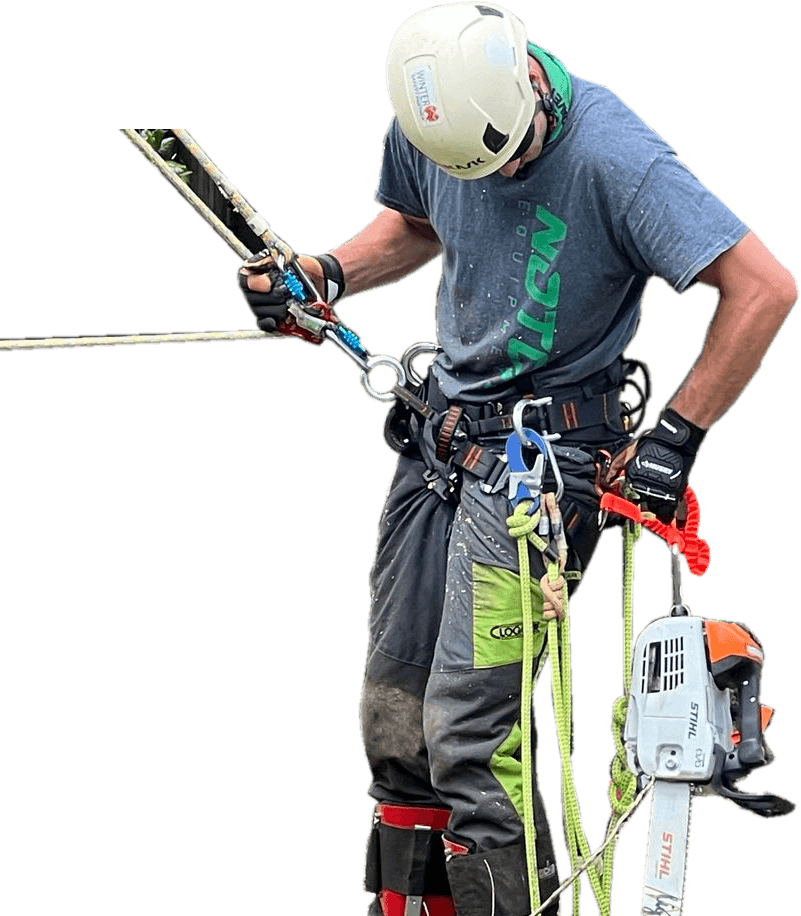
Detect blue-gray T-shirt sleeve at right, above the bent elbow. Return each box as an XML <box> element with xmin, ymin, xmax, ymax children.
<box><xmin>624</xmin><ymin>155</ymin><xmax>749</xmax><ymax>293</ymax></box>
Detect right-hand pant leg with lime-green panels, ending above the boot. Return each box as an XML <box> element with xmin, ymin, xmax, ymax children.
<box><xmin>424</xmin><ymin>479</ymin><xmax>560</xmax><ymax>852</ymax></box>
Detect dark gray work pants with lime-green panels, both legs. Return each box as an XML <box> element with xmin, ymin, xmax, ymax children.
<box><xmin>361</xmin><ymin>404</ymin><xmax>622</xmax><ymax>916</ymax></box>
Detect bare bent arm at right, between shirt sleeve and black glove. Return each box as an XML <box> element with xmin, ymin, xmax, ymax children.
<box><xmin>670</xmin><ymin>232</ymin><xmax>798</xmax><ymax>429</ymax></box>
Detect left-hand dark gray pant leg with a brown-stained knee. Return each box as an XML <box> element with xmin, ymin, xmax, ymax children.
<box><xmin>360</xmin><ymin>456</ymin><xmax>454</xmax><ymax>806</ymax></box>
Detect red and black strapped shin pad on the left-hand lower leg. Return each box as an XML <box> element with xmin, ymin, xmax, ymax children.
<box><xmin>364</xmin><ymin>804</ymin><xmax>455</xmax><ymax>916</ymax></box>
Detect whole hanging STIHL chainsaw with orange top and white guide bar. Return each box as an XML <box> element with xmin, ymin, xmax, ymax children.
<box><xmin>623</xmin><ymin>549</ymin><xmax>796</xmax><ymax>916</ymax></box>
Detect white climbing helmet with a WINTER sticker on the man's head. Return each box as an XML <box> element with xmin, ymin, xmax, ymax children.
<box><xmin>386</xmin><ymin>2</ymin><xmax>536</xmax><ymax>178</ymax></box>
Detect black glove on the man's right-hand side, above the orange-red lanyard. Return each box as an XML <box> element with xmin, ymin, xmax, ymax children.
<box><xmin>626</xmin><ymin>407</ymin><xmax>707</xmax><ymax>524</ymax></box>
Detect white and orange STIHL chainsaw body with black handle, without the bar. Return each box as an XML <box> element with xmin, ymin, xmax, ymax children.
<box><xmin>623</xmin><ymin>615</ymin><xmax>795</xmax><ymax>818</ymax></box>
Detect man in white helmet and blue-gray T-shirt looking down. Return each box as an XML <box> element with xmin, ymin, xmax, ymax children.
<box><xmin>238</xmin><ymin>3</ymin><xmax>798</xmax><ymax>916</ymax></box>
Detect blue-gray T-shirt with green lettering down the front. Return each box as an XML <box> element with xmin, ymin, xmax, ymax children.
<box><xmin>376</xmin><ymin>57</ymin><xmax>748</xmax><ymax>403</ymax></box>
